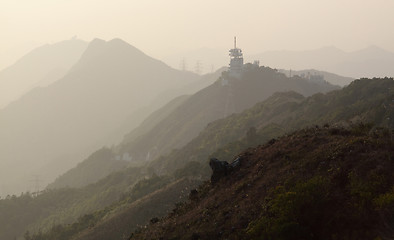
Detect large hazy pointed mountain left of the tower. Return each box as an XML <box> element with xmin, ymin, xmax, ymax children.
<box><xmin>0</xmin><ymin>39</ymin><xmax>207</xmax><ymax>194</ymax></box>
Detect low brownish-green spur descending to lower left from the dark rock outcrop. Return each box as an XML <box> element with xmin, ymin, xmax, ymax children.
<box><xmin>16</xmin><ymin>175</ymin><xmax>199</xmax><ymax>240</ymax></box>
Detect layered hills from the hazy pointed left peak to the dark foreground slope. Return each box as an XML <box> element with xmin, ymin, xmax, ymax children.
<box><xmin>0</xmin><ymin>35</ymin><xmax>394</xmax><ymax>240</ymax></box>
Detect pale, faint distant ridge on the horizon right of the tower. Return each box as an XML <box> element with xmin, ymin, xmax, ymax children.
<box><xmin>248</xmin><ymin>46</ymin><xmax>394</xmax><ymax>80</ymax></box>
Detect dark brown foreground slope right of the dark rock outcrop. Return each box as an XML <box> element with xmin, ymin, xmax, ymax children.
<box><xmin>130</xmin><ymin>125</ymin><xmax>394</xmax><ymax>239</ymax></box>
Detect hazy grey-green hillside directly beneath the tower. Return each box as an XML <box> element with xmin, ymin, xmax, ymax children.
<box><xmin>50</xmin><ymin>65</ymin><xmax>337</xmax><ymax>188</ymax></box>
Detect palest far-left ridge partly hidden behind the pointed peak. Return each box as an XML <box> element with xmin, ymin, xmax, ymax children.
<box><xmin>0</xmin><ymin>39</ymin><xmax>88</xmax><ymax>109</ymax></box>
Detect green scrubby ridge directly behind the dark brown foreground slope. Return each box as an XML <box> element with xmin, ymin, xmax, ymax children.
<box><xmin>4</xmin><ymin>79</ymin><xmax>394</xmax><ymax>239</ymax></box>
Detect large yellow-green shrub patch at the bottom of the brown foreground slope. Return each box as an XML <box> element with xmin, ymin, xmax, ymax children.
<box><xmin>247</xmin><ymin>177</ymin><xmax>330</xmax><ymax>239</ymax></box>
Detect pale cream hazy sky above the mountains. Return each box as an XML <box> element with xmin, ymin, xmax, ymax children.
<box><xmin>0</xmin><ymin>0</ymin><xmax>394</xmax><ymax>69</ymax></box>
